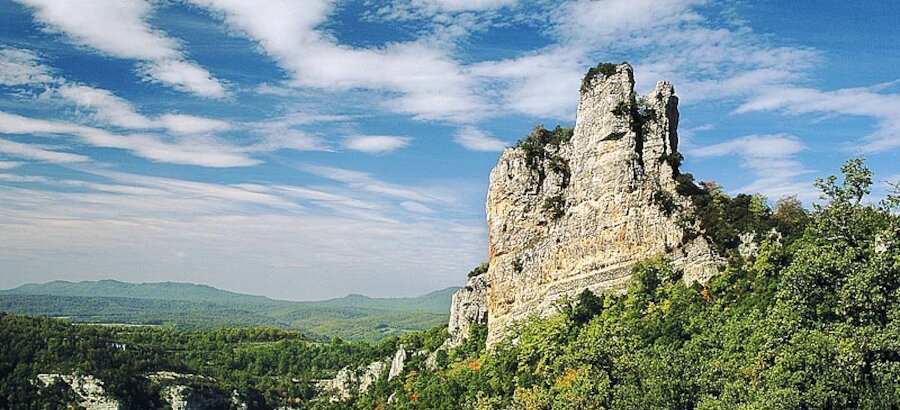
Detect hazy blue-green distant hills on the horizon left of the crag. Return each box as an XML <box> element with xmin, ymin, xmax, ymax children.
<box><xmin>0</xmin><ymin>279</ymin><xmax>458</xmax><ymax>342</ymax></box>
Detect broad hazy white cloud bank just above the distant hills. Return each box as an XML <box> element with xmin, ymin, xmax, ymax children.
<box><xmin>0</xmin><ymin>167</ymin><xmax>485</xmax><ymax>298</ymax></box>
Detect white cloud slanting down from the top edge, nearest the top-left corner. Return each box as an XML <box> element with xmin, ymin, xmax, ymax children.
<box><xmin>17</xmin><ymin>0</ymin><xmax>227</xmax><ymax>98</ymax></box>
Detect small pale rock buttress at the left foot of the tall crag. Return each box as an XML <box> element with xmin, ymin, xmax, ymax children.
<box><xmin>446</xmin><ymin>274</ymin><xmax>488</xmax><ymax>347</ymax></box>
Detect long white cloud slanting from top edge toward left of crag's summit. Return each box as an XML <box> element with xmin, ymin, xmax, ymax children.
<box><xmin>189</xmin><ymin>0</ymin><xmax>487</xmax><ymax>121</ymax></box>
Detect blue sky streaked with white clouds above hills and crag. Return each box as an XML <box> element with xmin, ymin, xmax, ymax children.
<box><xmin>0</xmin><ymin>0</ymin><xmax>900</xmax><ymax>300</ymax></box>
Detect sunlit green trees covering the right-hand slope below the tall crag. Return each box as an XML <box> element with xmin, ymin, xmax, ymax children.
<box><xmin>338</xmin><ymin>159</ymin><xmax>900</xmax><ymax>409</ymax></box>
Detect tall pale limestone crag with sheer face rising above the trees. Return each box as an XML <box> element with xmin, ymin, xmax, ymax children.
<box><xmin>482</xmin><ymin>64</ymin><xmax>719</xmax><ymax>344</ymax></box>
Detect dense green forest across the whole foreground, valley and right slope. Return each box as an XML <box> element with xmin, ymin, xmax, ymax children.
<box><xmin>0</xmin><ymin>160</ymin><xmax>900</xmax><ymax>409</ymax></box>
